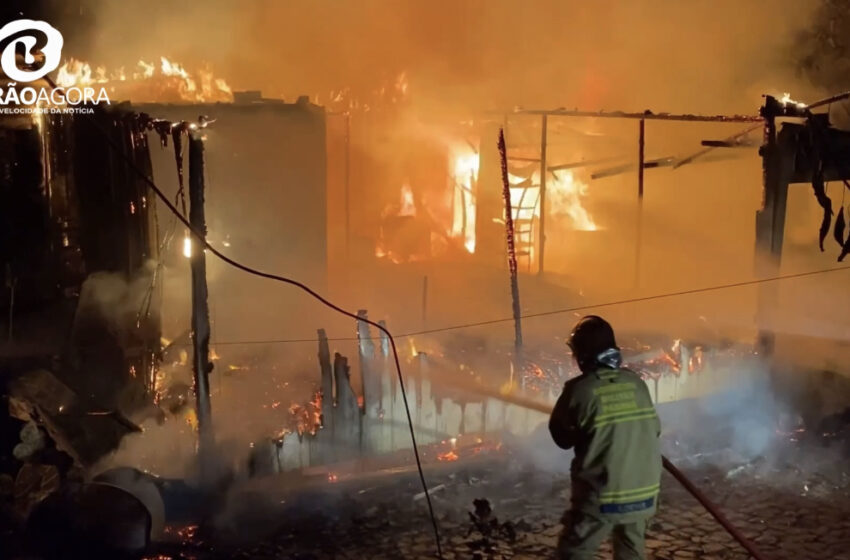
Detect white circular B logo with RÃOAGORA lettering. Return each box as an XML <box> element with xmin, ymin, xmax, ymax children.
<box><xmin>0</xmin><ymin>19</ymin><xmax>109</xmax><ymax>114</ymax></box>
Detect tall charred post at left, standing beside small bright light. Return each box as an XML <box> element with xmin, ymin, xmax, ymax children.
<box><xmin>189</xmin><ymin>133</ymin><xmax>213</xmax><ymax>464</ymax></box>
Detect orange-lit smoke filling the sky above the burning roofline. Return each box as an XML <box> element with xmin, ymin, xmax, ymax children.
<box><xmin>76</xmin><ymin>0</ymin><xmax>817</xmax><ymax>112</ymax></box>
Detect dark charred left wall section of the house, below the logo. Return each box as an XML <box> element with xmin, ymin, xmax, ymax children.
<box><xmin>0</xmin><ymin>94</ymin><xmax>160</xmax><ymax>464</ymax></box>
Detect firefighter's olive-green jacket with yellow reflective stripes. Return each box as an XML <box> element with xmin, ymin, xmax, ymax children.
<box><xmin>549</xmin><ymin>368</ymin><xmax>661</xmax><ymax>523</ymax></box>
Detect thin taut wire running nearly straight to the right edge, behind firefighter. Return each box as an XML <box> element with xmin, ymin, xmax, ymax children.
<box><xmin>174</xmin><ymin>266</ymin><xmax>850</xmax><ymax>346</ymax></box>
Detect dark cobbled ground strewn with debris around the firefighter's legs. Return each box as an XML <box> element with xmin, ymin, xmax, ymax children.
<box><xmin>126</xmin><ymin>426</ymin><xmax>850</xmax><ymax>560</ymax></box>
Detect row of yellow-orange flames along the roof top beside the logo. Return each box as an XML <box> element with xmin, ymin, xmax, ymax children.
<box><xmin>56</xmin><ymin>56</ymin><xmax>233</xmax><ymax>103</ymax></box>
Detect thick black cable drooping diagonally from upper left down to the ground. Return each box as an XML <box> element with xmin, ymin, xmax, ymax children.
<box><xmin>57</xmin><ymin>88</ymin><xmax>443</xmax><ymax>559</ymax></box>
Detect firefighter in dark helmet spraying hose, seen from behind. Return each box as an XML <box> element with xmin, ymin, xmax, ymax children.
<box><xmin>549</xmin><ymin>315</ymin><xmax>661</xmax><ymax>560</ymax></box>
